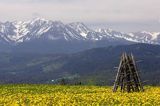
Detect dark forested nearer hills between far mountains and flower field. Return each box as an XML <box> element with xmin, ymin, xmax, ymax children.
<box><xmin>0</xmin><ymin>44</ymin><xmax>160</xmax><ymax>85</ymax></box>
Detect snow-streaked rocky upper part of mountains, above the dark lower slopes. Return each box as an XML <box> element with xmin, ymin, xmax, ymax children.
<box><xmin>0</xmin><ymin>18</ymin><xmax>160</xmax><ymax>44</ymax></box>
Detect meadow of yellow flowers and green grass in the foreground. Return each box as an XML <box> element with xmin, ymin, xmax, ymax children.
<box><xmin>0</xmin><ymin>85</ymin><xmax>160</xmax><ymax>106</ymax></box>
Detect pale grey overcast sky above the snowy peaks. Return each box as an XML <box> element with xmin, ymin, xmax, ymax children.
<box><xmin>0</xmin><ymin>0</ymin><xmax>160</xmax><ymax>32</ymax></box>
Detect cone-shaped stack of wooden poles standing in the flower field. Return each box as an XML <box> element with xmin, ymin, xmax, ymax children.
<box><xmin>113</xmin><ymin>53</ymin><xmax>143</xmax><ymax>92</ymax></box>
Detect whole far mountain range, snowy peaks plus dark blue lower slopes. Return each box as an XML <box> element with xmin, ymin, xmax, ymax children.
<box><xmin>0</xmin><ymin>18</ymin><xmax>160</xmax><ymax>54</ymax></box>
